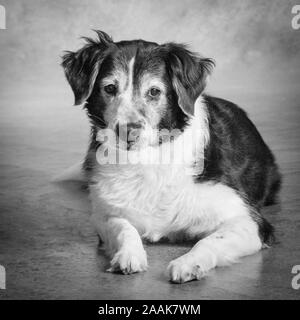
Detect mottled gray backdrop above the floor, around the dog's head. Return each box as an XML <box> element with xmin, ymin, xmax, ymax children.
<box><xmin>0</xmin><ymin>0</ymin><xmax>300</xmax><ymax>99</ymax></box>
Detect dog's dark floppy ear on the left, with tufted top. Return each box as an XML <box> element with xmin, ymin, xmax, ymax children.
<box><xmin>62</xmin><ymin>30</ymin><xmax>113</xmax><ymax>105</ymax></box>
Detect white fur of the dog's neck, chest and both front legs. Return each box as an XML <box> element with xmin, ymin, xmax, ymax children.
<box><xmin>90</xmin><ymin>98</ymin><xmax>261</xmax><ymax>282</ymax></box>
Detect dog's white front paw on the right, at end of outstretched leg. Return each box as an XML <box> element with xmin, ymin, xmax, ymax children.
<box><xmin>167</xmin><ymin>256</ymin><xmax>205</xmax><ymax>283</ymax></box>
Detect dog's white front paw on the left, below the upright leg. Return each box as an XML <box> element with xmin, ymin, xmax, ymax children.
<box><xmin>107</xmin><ymin>248</ymin><xmax>148</xmax><ymax>274</ymax></box>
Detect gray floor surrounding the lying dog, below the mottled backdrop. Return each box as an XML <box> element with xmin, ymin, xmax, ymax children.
<box><xmin>0</xmin><ymin>88</ymin><xmax>300</xmax><ymax>299</ymax></box>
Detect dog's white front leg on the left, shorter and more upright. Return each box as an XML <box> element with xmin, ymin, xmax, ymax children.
<box><xmin>92</xmin><ymin>210</ymin><xmax>147</xmax><ymax>274</ymax></box>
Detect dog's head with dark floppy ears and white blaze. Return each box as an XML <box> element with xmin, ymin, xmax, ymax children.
<box><xmin>62</xmin><ymin>31</ymin><xmax>214</xmax><ymax>149</ymax></box>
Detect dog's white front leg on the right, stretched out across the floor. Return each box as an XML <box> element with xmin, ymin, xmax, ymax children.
<box><xmin>168</xmin><ymin>215</ymin><xmax>262</xmax><ymax>283</ymax></box>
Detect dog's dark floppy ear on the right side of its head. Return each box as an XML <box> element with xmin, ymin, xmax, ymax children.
<box><xmin>163</xmin><ymin>43</ymin><xmax>215</xmax><ymax>115</ymax></box>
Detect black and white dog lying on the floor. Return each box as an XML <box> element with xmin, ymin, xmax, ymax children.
<box><xmin>62</xmin><ymin>31</ymin><xmax>280</xmax><ymax>283</ymax></box>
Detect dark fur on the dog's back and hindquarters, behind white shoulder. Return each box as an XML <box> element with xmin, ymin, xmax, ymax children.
<box><xmin>195</xmin><ymin>95</ymin><xmax>281</xmax><ymax>243</ymax></box>
